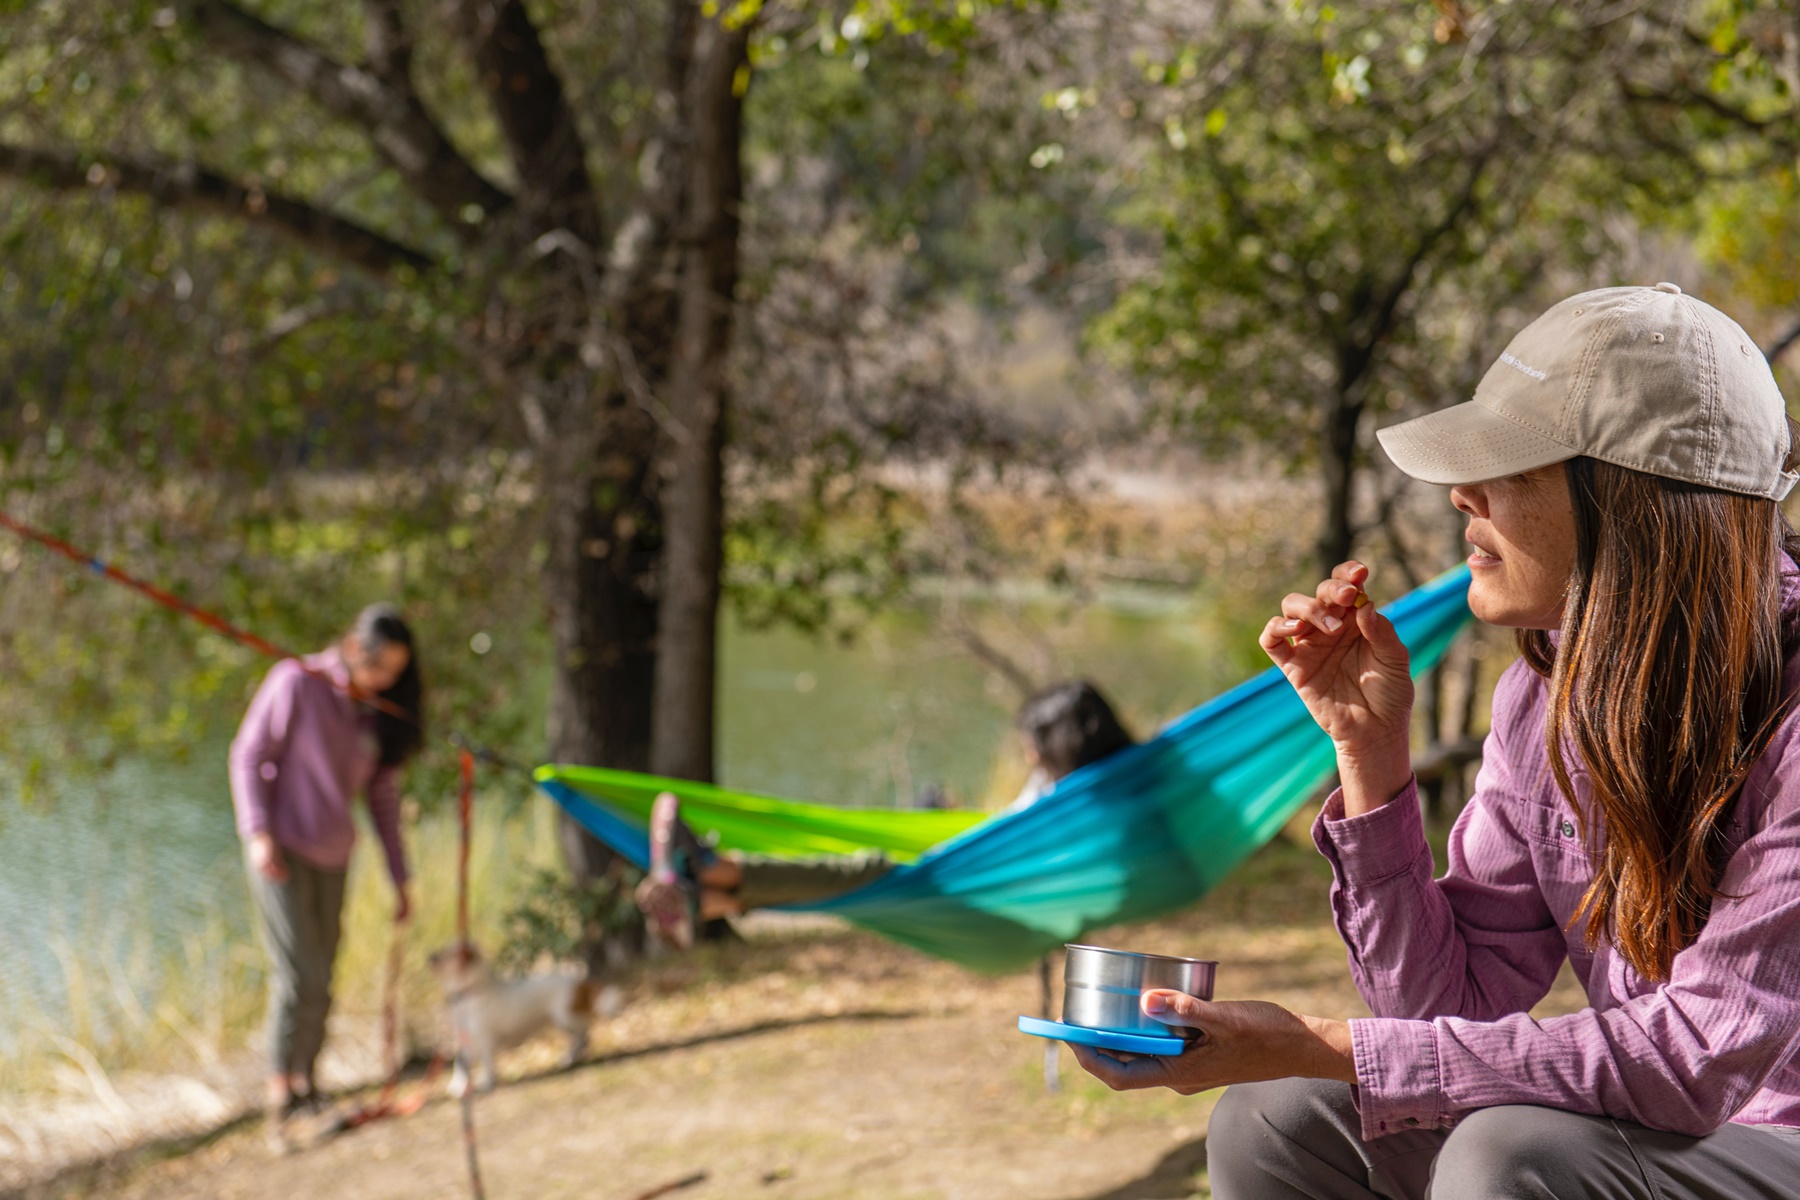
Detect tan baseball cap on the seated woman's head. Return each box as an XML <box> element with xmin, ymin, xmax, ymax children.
<box><xmin>1375</xmin><ymin>282</ymin><xmax>1800</xmax><ymax>500</ymax></box>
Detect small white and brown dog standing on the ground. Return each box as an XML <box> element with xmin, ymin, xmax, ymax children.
<box><xmin>427</xmin><ymin>943</ymin><xmax>623</xmax><ymax>1096</ymax></box>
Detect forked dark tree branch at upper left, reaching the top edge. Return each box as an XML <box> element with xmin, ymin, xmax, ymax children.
<box><xmin>189</xmin><ymin>0</ymin><xmax>511</xmax><ymax>234</ymax></box>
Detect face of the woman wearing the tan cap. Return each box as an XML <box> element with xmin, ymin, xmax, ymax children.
<box><xmin>1451</xmin><ymin>462</ymin><xmax>1575</xmax><ymax>630</ymax></box>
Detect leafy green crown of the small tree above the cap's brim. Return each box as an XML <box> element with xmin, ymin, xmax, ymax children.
<box><xmin>1093</xmin><ymin>4</ymin><xmax>1622</xmax><ymax>449</ymax></box>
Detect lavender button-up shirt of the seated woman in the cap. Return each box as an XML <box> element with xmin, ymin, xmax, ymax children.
<box><xmin>1312</xmin><ymin>633</ymin><xmax>1800</xmax><ymax>1139</ymax></box>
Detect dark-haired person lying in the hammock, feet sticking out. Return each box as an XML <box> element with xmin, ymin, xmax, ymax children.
<box><xmin>637</xmin><ymin>680</ymin><xmax>1136</xmax><ymax>948</ymax></box>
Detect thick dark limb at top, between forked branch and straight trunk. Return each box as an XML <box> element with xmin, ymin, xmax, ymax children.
<box><xmin>457</xmin><ymin>0</ymin><xmax>601</xmax><ymax>254</ymax></box>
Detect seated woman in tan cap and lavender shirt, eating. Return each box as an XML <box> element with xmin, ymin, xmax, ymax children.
<box><xmin>1082</xmin><ymin>284</ymin><xmax>1800</xmax><ymax>1200</ymax></box>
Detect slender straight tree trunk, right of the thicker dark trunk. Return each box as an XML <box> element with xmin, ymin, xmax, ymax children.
<box><xmin>650</xmin><ymin>11</ymin><xmax>749</xmax><ymax>783</ymax></box>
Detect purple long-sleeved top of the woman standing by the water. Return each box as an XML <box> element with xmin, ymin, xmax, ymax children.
<box><xmin>230</xmin><ymin>649</ymin><xmax>407</xmax><ymax>885</ymax></box>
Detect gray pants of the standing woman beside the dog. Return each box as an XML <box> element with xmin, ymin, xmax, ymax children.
<box><xmin>250</xmin><ymin>855</ymin><xmax>344</xmax><ymax>1079</ymax></box>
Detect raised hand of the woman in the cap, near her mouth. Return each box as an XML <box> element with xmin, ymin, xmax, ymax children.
<box><xmin>1260</xmin><ymin>561</ymin><xmax>1413</xmax><ymax>817</ymax></box>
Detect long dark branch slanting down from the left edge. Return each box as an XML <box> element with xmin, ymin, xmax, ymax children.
<box><xmin>0</xmin><ymin>144</ymin><xmax>432</xmax><ymax>275</ymax></box>
